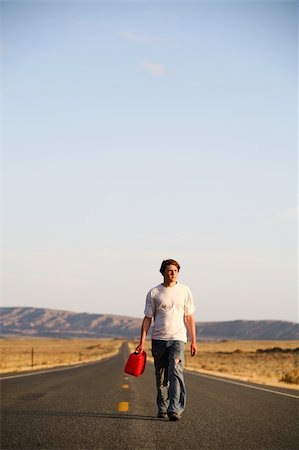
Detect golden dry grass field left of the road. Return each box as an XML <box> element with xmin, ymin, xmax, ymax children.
<box><xmin>0</xmin><ymin>338</ymin><xmax>124</xmax><ymax>373</ymax></box>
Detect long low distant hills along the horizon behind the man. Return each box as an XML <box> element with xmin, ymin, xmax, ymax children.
<box><xmin>0</xmin><ymin>308</ymin><xmax>299</xmax><ymax>340</ymax></box>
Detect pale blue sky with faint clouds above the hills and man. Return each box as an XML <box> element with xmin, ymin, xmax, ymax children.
<box><xmin>0</xmin><ymin>0</ymin><xmax>298</xmax><ymax>321</ymax></box>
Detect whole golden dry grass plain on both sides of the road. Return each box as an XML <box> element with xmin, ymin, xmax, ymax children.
<box><xmin>0</xmin><ymin>338</ymin><xmax>299</xmax><ymax>390</ymax></box>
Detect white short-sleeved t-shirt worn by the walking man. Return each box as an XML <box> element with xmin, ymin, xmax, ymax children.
<box><xmin>144</xmin><ymin>283</ymin><xmax>195</xmax><ymax>342</ymax></box>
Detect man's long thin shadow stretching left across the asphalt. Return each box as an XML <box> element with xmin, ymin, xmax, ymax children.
<box><xmin>2</xmin><ymin>410</ymin><xmax>165</xmax><ymax>421</ymax></box>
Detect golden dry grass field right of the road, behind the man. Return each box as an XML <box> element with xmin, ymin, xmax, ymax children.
<box><xmin>131</xmin><ymin>341</ymin><xmax>299</xmax><ymax>390</ymax></box>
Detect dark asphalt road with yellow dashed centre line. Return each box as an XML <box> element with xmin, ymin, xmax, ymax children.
<box><xmin>0</xmin><ymin>342</ymin><xmax>299</xmax><ymax>450</ymax></box>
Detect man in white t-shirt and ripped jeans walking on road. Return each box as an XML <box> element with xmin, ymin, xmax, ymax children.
<box><xmin>136</xmin><ymin>259</ymin><xmax>197</xmax><ymax>421</ymax></box>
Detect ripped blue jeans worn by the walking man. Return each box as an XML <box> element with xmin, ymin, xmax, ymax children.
<box><xmin>152</xmin><ymin>339</ymin><xmax>186</xmax><ymax>414</ymax></box>
